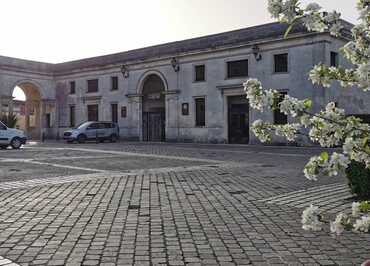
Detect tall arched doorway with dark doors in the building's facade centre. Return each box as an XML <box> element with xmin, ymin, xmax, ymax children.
<box><xmin>142</xmin><ymin>74</ymin><xmax>166</xmax><ymax>141</ymax></box>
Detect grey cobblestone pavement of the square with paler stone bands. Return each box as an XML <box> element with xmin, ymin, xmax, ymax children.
<box><xmin>0</xmin><ymin>143</ymin><xmax>370</xmax><ymax>265</ymax></box>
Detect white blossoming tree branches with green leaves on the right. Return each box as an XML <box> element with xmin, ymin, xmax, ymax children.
<box><xmin>244</xmin><ymin>0</ymin><xmax>370</xmax><ymax>234</ymax></box>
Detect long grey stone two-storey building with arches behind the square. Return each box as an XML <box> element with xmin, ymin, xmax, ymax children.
<box><xmin>0</xmin><ymin>22</ymin><xmax>370</xmax><ymax>143</ymax></box>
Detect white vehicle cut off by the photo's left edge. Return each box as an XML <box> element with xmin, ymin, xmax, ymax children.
<box><xmin>0</xmin><ymin>121</ymin><xmax>27</xmax><ymax>149</ymax></box>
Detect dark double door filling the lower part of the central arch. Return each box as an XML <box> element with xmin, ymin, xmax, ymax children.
<box><xmin>143</xmin><ymin>111</ymin><xmax>166</xmax><ymax>141</ymax></box>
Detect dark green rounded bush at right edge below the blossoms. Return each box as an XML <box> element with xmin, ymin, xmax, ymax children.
<box><xmin>346</xmin><ymin>161</ymin><xmax>370</xmax><ymax>200</ymax></box>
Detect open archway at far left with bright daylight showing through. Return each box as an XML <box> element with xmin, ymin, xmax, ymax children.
<box><xmin>10</xmin><ymin>82</ymin><xmax>42</xmax><ymax>140</ymax></box>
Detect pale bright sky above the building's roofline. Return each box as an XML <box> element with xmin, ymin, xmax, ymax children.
<box><xmin>0</xmin><ymin>0</ymin><xmax>357</xmax><ymax>62</ymax></box>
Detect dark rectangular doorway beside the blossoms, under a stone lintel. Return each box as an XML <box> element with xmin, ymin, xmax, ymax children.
<box><xmin>228</xmin><ymin>96</ymin><xmax>249</xmax><ymax>144</ymax></box>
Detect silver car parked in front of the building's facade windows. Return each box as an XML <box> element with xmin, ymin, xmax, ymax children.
<box><xmin>63</xmin><ymin>121</ymin><xmax>119</xmax><ymax>143</ymax></box>
